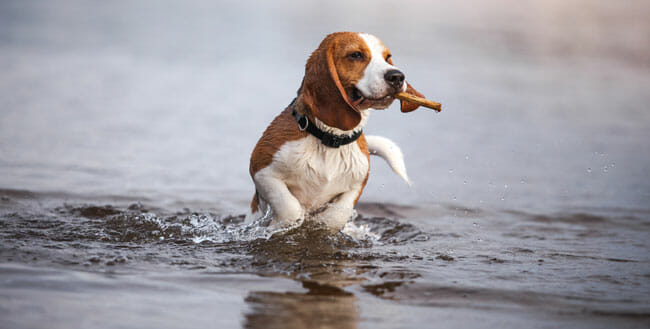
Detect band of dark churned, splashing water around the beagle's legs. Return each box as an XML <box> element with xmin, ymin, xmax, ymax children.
<box><xmin>57</xmin><ymin>204</ymin><xmax>424</xmax><ymax>246</ymax></box>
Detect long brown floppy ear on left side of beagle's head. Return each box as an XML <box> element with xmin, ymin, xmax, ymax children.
<box><xmin>300</xmin><ymin>34</ymin><xmax>361</xmax><ymax>130</ymax></box>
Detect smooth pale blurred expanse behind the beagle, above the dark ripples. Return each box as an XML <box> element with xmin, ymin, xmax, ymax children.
<box><xmin>0</xmin><ymin>0</ymin><xmax>650</xmax><ymax>213</ymax></box>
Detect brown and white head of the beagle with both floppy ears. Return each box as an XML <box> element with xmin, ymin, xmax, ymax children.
<box><xmin>301</xmin><ymin>32</ymin><xmax>423</xmax><ymax>130</ymax></box>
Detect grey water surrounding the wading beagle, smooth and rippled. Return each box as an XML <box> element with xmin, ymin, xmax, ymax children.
<box><xmin>0</xmin><ymin>1</ymin><xmax>650</xmax><ymax>328</ymax></box>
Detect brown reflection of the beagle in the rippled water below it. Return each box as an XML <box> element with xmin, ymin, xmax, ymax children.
<box><xmin>245</xmin><ymin>223</ymin><xmax>364</xmax><ymax>328</ymax></box>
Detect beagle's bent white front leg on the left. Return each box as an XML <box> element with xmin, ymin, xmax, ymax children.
<box><xmin>253</xmin><ymin>169</ymin><xmax>304</xmax><ymax>228</ymax></box>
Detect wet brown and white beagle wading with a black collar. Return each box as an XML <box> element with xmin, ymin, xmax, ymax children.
<box><xmin>250</xmin><ymin>32</ymin><xmax>424</xmax><ymax>233</ymax></box>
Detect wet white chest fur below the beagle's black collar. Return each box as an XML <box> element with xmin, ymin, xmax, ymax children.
<box><xmin>262</xmin><ymin>135</ymin><xmax>369</xmax><ymax>213</ymax></box>
